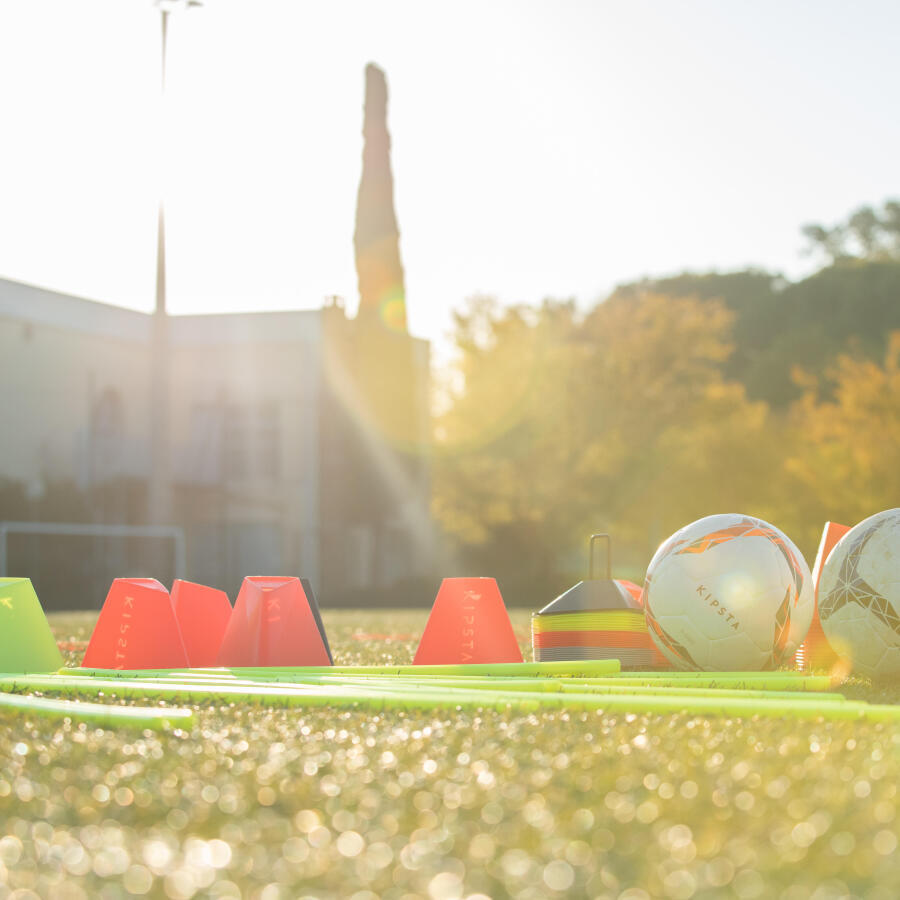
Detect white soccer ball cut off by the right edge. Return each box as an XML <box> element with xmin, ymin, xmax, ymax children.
<box><xmin>819</xmin><ymin>509</ymin><xmax>900</xmax><ymax>677</ymax></box>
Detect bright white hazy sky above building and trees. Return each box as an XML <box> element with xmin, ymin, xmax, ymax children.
<box><xmin>0</xmin><ymin>0</ymin><xmax>900</xmax><ymax>345</ymax></box>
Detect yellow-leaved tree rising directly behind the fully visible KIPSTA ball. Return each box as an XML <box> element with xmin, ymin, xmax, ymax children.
<box><xmin>586</xmin><ymin>294</ymin><xmax>775</xmax><ymax>551</ymax></box>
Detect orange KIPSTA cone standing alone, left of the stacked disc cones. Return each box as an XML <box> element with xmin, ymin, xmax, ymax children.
<box><xmin>413</xmin><ymin>578</ymin><xmax>523</xmax><ymax>665</ymax></box>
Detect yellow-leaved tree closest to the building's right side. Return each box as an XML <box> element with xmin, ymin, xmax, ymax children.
<box><xmin>434</xmin><ymin>297</ymin><xmax>584</xmax><ymax>583</ymax></box>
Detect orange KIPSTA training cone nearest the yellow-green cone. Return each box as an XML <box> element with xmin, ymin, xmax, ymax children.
<box><xmin>82</xmin><ymin>578</ymin><xmax>188</xmax><ymax>669</ymax></box>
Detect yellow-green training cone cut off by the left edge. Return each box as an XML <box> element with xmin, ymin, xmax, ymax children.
<box><xmin>0</xmin><ymin>578</ymin><xmax>63</xmax><ymax>673</ymax></box>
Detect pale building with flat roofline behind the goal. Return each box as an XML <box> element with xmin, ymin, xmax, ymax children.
<box><xmin>0</xmin><ymin>279</ymin><xmax>431</xmax><ymax>606</ymax></box>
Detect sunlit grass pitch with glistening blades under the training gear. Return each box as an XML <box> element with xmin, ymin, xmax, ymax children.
<box><xmin>0</xmin><ymin>611</ymin><xmax>900</xmax><ymax>900</ymax></box>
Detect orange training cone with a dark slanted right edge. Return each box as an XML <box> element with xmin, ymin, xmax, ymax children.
<box><xmin>217</xmin><ymin>575</ymin><xmax>331</xmax><ymax>666</ymax></box>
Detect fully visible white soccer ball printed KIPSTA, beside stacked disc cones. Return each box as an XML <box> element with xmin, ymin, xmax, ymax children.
<box><xmin>644</xmin><ymin>514</ymin><xmax>814</xmax><ymax>671</ymax></box>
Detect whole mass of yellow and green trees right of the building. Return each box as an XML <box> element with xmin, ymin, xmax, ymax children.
<box><xmin>434</xmin><ymin>202</ymin><xmax>900</xmax><ymax>604</ymax></box>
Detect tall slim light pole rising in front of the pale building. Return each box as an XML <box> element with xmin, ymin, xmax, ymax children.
<box><xmin>147</xmin><ymin>0</ymin><xmax>202</xmax><ymax>525</ymax></box>
